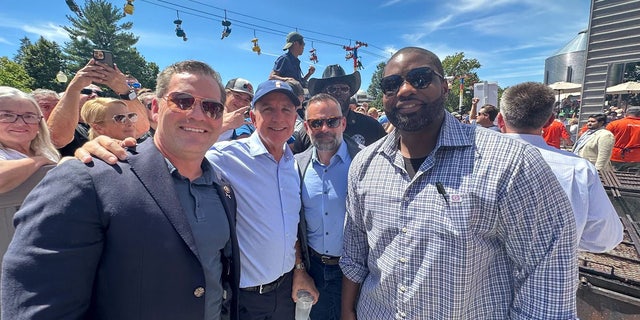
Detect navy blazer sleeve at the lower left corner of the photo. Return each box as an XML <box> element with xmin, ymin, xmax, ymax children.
<box><xmin>1</xmin><ymin>160</ymin><xmax>104</xmax><ymax>319</ymax></box>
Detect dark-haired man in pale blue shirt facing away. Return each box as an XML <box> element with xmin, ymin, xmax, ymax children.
<box><xmin>498</xmin><ymin>82</ymin><xmax>623</xmax><ymax>252</ymax></box>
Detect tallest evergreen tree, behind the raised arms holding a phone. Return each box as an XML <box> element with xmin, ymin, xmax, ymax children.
<box><xmin>62</xmin><ymin>0</ymin><xmax>159</xmax><ymax>88</ymax></box>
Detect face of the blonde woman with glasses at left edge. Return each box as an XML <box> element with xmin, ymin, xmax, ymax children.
<box><xmin>0</xmin><ymin>97</ymin><xmax>43</xmax><ymax>156</ymax></box>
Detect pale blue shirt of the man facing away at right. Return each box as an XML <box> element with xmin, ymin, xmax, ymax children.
<box><xmin>507</xmin><ymin>133</ymin><xmax>623</xmax><ymax>252</ymax></box>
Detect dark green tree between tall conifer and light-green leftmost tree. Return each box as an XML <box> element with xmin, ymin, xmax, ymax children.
<box><xmin>16</xmin><ymin>37</ymin><xmax>65</xmax><ymax>91</ymax></box>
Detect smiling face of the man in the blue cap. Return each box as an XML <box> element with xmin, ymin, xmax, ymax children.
<box><xmin>250</xmin><ymin>91</ymin><xmax>298</xmax><ymax>158</ymax></box>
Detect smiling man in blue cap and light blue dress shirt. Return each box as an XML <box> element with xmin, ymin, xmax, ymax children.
<box><xmin>206</xmin><ymin>80</ymin><xmax>318</xmax><ymax>320</ymax></box>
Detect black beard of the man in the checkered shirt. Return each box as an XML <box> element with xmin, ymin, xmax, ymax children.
<box><xmin>385</xmin><ymin>95</ymin><xmax>444</xmax><ymax>132</ymax></box>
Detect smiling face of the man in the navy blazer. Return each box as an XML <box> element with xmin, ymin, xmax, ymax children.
<box><xmin>153</xmin><ymin>73</ymin><xmax>222</xmax><ymax>165</ymax></box>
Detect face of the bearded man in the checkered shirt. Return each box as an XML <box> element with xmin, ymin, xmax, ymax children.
<box><xmin>382</xmin><ymin>51</ymin><xmax>447</xmax><ymax>132</ymax></box>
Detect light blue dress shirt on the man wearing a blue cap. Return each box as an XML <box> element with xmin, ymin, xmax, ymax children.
<box><xmin>206</xmin><ymin>131</ymin><xmax>300</xmax><ymax>288</ymax></box>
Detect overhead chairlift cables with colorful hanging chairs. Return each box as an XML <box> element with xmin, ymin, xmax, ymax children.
<box><xmin>124</xmin><ymin>0</ymin><xmax>390</xmax><ymax>70</ymax></box>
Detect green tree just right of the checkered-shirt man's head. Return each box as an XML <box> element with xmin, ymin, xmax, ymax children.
<box><xmin>442</xmin><ymin>52</ymin><xmax>481</xmax><ymax>112</ymax></box>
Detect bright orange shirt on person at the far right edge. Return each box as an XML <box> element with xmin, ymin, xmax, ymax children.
<box><xmin>607</xmin><ymin>116</ymin><xmax>640</xmax><ymax>162</ymax></box>
